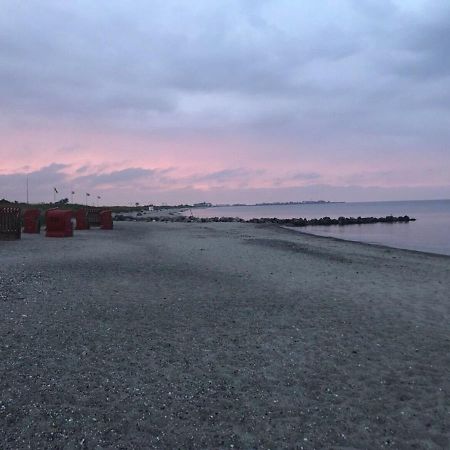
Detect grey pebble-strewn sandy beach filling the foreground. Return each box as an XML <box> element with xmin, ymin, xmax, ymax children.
<box><xmin>0</xmin><ymin>223</ymin><xmax>450</xmax><ymax>449</ymax></box>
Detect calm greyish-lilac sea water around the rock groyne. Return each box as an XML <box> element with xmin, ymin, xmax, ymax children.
<box><xmin>192</xmin><ymin>200</ymin><xmax>450</xmax><ymax>255</ymax></box>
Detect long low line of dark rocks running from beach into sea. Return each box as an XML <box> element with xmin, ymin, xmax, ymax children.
<box><xmin>114</xmin><ymin>214</ymin><xmax>416</xmax><ymax>227</ymax></box>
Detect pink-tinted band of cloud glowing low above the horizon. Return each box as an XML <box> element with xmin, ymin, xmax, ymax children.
<box><xmin>0</xmin><ymin>119</ymin><xmax>450</xmax><ymax>202</ymax></box>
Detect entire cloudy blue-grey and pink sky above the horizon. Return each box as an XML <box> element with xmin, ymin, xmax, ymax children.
<box><xmin>0</xmin><ymin>0</ymin><xmax>450</xmax><ymax>204</ymax></box>
